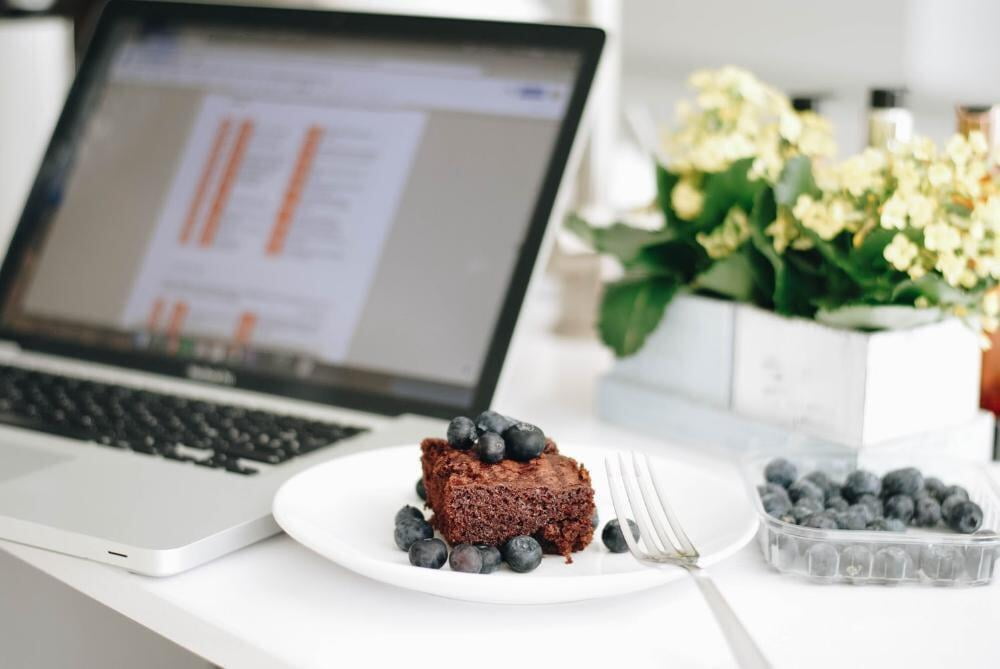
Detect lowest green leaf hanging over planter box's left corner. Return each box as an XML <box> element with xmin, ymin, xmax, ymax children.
<box><xmin>598</xmin><ymin>275</ymin><xmax>678</xmax><ymax>357</ymax></box>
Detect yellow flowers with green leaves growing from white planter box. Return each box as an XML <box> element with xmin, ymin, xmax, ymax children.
<box><xmin>568</xmin><ymin>67</ymin><xmax>1000</xmax><ymax>356</ymax></box>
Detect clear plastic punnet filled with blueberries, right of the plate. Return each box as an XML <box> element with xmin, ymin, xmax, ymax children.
<box><xmin>743</xmin><ymin>446</ymin><xmax>1000</xmax><ymax>586</ymax></box>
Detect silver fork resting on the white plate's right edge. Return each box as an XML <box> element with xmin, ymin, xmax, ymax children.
<box><xmin>604</xmin><ymin>453</ymin><xmax>771</xmax><ymax>669</ymax></box>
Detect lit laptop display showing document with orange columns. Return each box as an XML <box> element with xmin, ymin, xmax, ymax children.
<box><xmin>3</xmin><ymin>11</ymin><xmax>581</xmax><ymax>412</ymax></box>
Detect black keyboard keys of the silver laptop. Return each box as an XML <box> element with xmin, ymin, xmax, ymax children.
<box><xmin>0</xmin><ymin>365</ymin><xmax>366</xmax><ymax>475</ymax></box>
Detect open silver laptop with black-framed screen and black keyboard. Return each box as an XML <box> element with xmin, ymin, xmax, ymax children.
<box><xmin>0</xmin><ymin>0</ymin><xmax>603</xmax><ymax>576</ymax></box>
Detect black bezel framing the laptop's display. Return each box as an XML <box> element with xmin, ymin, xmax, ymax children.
<box><xmin>0</xmin><ymin>0</ymin><xmax>604</xmax><ymax>417</ymax></box>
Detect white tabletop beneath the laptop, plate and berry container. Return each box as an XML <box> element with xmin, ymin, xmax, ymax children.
<box><xmin>0</xmin><ymin>284</ymin><xmax>1000</xmax><ymax>669</ymax></box>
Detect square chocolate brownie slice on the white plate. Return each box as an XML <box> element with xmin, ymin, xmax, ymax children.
<box><xmin>420</xmin><ymin>439</ymin><xmax>594</xmax><ymax>562</ymax></box>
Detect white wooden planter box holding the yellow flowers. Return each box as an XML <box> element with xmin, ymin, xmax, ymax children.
<box><xmin>601</xmin><ymin>295</ymin><xmax>985</xmax><ymax>448</ymax></box>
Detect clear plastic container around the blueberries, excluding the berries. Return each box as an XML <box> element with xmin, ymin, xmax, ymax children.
<box><xmin>743</xmin><ymin>452</ymin><xmax>1000</xmax><ymax>586</ymax></box>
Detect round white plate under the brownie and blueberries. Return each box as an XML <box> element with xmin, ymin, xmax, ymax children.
<box><xmin>274</xmin><ymin>444</ymin><xmax>757</xmax><ymax>604</ymax></box>
